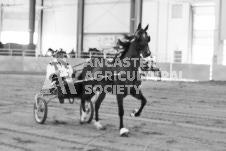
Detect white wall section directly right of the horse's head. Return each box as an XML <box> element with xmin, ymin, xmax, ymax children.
<box><xmin>142</xmin><ymin>0</ymin><xmax>190</xmax><ymax>63</ymax></box>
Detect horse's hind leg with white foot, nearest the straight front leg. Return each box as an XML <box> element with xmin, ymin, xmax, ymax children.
<box><xmin>94</xmin><ymin>92</ymin><xmax>106</xmax><ymax>130</ymax></box>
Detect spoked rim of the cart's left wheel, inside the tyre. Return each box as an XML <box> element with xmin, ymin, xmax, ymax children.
<box><xmin>35</xmin><ymin>99</ymin><xmax>46</xmax><ymax>122</ymax></box>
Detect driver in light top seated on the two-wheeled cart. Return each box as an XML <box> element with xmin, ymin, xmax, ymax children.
<box><xmin>46</xmin><ymin>51</ymin><xmax>73</xmax><ymax>104</ymax></box>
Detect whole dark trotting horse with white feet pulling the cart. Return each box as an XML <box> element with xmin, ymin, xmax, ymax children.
<box><xmin>78</xmin><ymin>24</ymin><xmax>151</xmax><ymax>136</ymax></box>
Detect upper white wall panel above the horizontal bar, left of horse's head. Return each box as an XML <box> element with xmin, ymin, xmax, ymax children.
<box><xmin>84</xmin><ymin>0</ymin><xmax>130</xmax><ymax>33</ymax></box>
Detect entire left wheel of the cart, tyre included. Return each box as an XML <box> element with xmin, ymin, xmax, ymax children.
<box><xmin>34</xmin><ymin>98</ymin><xmax>48</xmax><ymax>124</ymax></box>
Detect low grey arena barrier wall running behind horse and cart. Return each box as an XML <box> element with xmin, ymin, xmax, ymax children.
<box><xmin>0</xmin><ymin>56</ymin><xmax>212</xmax><ymax>81</ymax></box>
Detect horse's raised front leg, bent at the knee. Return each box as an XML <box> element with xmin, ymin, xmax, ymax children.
<box><xmin>130</xmin><ymin>90</ymin><xmax>147</xmax><ymax>117</ymax></box>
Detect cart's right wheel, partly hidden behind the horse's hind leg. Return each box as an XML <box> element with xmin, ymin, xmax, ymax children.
<box><xmin>80</xmin><ymin>101</ymin><xmax>94</xmax><ymax>124</ymax></box>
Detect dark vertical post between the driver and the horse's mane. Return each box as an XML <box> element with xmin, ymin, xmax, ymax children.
<box><xmin>76</xmin><ymin>0</ymin><xmax>85</xmax><ymax>54</ymax></box>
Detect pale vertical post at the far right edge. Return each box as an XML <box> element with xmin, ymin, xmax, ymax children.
<box><xmin>213</xmin><ymin>0</ymin><xmax>223</xmax><ymax>64</ymax></box>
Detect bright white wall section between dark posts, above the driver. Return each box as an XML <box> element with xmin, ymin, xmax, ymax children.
<box><xmin>41</xmin><ymin>0</ymin><xmax>77</xmax><ymax>54</ymax></box>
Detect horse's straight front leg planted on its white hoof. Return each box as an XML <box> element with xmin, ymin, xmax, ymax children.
<box><xmin>117</xmin><ymin>95</ymin><xmax>129</xmax><ymax>137</ymax></box>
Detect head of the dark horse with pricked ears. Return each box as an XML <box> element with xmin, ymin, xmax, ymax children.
<box><xmin>131</xmin><ymin>24</ymin><xmax>151</xmax><ymax>58</ymax></box>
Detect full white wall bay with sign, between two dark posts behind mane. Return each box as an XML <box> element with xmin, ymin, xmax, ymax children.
<box><xmin>83</xmin><ymin>0</ymin><xmax>130</xmax><ymax>51</ymax></box>
